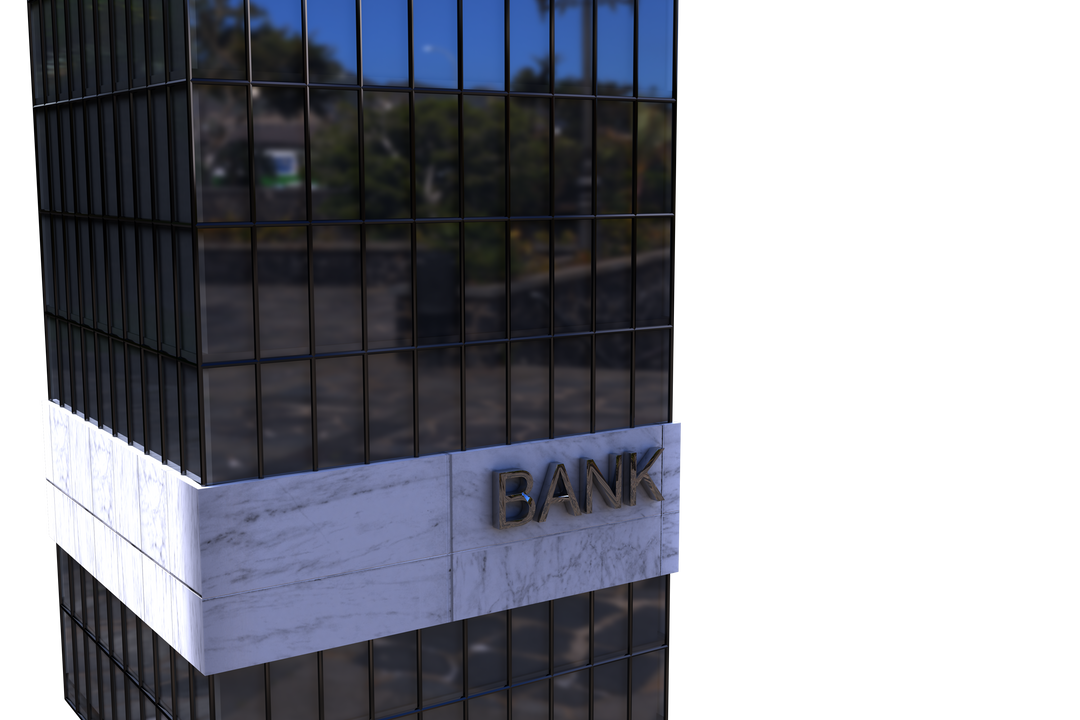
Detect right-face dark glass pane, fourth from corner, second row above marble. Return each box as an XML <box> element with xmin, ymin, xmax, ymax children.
<box><xmin>365</xmin><ymin>225</ymin><xmax>413</xmax><ymax>349</ymax></box>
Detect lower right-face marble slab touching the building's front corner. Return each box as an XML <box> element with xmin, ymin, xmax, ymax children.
<box><xmin>202</xmin><ymin>556</ymin><xmax>450</xmax><ymax>674</ymax></box>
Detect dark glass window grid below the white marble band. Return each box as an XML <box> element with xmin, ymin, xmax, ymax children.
<box><xmin>55</xmin><ymin>546</ymin><xmax>671</xmax><ymax>720</ymax></box>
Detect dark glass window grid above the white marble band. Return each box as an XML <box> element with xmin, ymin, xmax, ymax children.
<box><xmin>28</xmin><ymin>0</ymin><xmax>678</xmax><ymax>483</ymax></box>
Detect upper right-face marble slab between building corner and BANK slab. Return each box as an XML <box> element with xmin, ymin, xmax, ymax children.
<box><xmin>198</xmin><ymin>454</ymin><xmax>447</xmax><ymax>597</ymax></box>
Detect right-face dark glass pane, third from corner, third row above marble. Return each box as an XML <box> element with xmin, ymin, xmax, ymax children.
<box><xmin>310</xmin><ymin>89</ymin><xmax>360</xmax><ymax>220</ymax></box>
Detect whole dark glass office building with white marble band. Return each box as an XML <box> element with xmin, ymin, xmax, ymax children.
<box><xmin>35</xmin><ymin>0</ymin><xmax>684</xmax><ymax>720</ymax></box>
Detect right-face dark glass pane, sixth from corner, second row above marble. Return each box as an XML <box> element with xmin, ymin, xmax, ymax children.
<box><xmin>464</xmin><ymin>222</ymin><xmax>507</xmax><ymax>341</ymax></box>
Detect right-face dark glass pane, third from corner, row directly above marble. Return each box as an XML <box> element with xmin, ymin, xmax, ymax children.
<box><xmin>315</xmin><ymin>355</ymin><xmax>364</xmax><ymax>468</ymax></box>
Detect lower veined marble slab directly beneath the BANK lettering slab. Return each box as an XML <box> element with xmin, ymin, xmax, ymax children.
<box><xmin>454</xmin><ymin>515</ymin><xmax>661</xmax><ymax>620</ymax></box>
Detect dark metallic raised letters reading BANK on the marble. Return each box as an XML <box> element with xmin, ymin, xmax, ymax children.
<box><xmin>491</xmin><ymin>448</ymin><xmax>664</xmax><ymax>530</ymax></box>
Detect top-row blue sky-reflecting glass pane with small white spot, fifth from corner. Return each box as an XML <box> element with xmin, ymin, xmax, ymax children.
<box><xmin>413</xmin><ymin>0</ymin><xmax>458</xmax><ymax>87</ymax></box>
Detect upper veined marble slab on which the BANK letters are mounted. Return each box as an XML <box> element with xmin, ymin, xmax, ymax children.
<box><xmin>450</xmin><ymin>425</ymin><xmax>663</xmax><ymax>553</ymax></box>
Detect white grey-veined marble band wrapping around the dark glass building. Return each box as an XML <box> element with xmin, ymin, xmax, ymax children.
<box><xmin>40</xmin><ymin>400</ymin><xmax>683</xmax><ymax>674</ymax></box>
